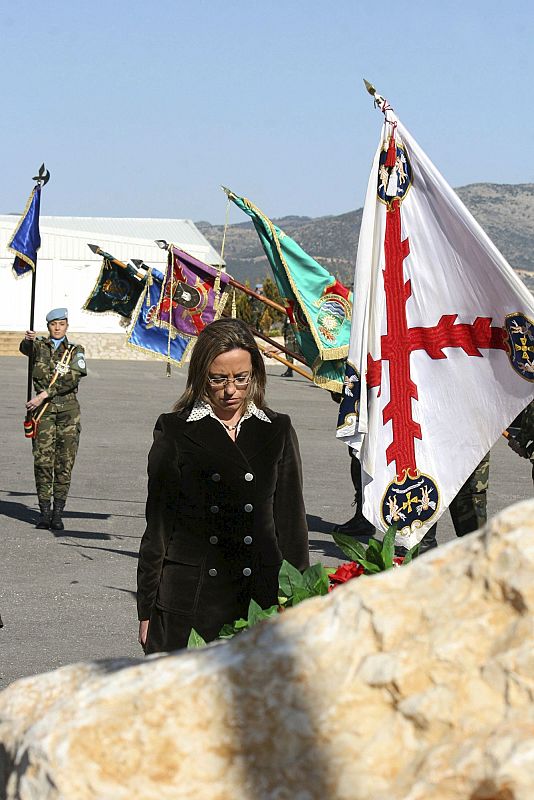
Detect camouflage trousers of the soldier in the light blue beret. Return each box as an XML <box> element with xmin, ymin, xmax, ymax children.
<box><xmin>33</xmin><ymin>401</ymin><xmax>81</xmax><ymax>500</ymax></box>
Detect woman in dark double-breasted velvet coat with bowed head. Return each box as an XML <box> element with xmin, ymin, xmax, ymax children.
<box><xmin>137</xmin><ymin>319</ymin><xmax>309</xmax><ymax>653</ymax></box>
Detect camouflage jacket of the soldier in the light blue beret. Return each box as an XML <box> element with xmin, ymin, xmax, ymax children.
<box><xmin>19</xmin><ymin>336</ymin><xmax>87</xmax><ymax>405</ymax></box>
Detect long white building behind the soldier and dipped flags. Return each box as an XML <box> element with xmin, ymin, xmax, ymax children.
<box><xmin>0</xmin><ymin>214</ymin><xmax>220</xmax><ymax>334</ymax></box>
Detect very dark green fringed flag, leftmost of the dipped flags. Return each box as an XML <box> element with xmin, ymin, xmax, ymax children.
<box><xmin>83</xmin><ymin>253</ymin><xmax>146</xmax><ymax>317</ymax></box>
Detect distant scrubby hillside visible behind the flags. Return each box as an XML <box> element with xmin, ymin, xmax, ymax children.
<box><xmin>196</xmin><ymin>183</ymin><xmax>534</xmax><ymax>290</ymax></box>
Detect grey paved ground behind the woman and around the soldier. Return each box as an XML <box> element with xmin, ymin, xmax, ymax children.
<box><xmin>0</xmin><ymin>357</ymin><xmax>532</xmax><ymax>689</ymax></box>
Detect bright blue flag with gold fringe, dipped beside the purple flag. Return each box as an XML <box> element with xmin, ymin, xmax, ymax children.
<box><xmin>127</xmin><ymin>269</ymin><xmax>196</xmax><ymax>365</ymax></box>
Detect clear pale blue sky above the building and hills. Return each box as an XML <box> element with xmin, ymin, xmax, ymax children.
<box><xmin>0</xmin><ymin>0</ymin><xmax>534</xmax><ymax>222</ymax></box>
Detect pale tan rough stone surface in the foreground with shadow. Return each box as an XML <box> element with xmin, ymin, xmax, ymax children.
<box><xmin>0</xmin><ymin>500</ymin><xmax>534</xmax><ymax>800</ymax></box>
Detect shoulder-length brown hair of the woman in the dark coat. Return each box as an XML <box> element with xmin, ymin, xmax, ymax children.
<box><xmin>173</xmin><ymin>318</ymin><xmax>267</xmax><ymax>411</ymax></box>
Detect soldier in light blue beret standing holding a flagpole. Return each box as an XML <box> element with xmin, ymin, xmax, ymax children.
<box><xmin>20</xmin><ymin>308</ymin><xmax>87</xmax><ymax>531</ymax></box>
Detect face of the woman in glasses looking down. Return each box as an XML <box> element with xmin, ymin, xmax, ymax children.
<box><xmin>206</xmin><ymin>349</ymin><xmax>252</xmax><ymax>419</ymax></box>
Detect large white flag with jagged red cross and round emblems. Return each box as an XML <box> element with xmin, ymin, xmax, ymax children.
<box><xmin>337</xmin><ymin>90</ymin><xmax>534</xmax><ymax>547</ymax></box>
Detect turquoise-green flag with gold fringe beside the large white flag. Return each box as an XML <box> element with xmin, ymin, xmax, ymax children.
<box><xmin>225</xmin><ymin>189</ymin><xmax>352</xmax><ymax>392</ymax></box>
